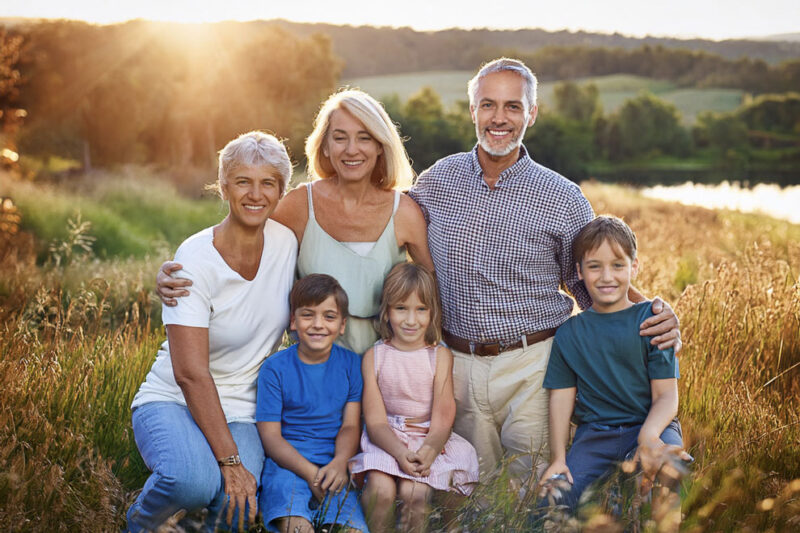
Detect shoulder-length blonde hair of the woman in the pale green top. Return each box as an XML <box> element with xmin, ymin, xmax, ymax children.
<box><xmin>306</xmin><ymin>89</ymin><xmax>414</xmax><ymax>191</ymax></box>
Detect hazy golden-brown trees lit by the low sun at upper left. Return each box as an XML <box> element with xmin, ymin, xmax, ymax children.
<box><xmin>0</xmin><ymin>21</ymin><xmax>341</xmax><ymax>167</ymax></box>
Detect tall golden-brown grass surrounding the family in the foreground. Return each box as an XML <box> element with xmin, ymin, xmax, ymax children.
<box><xmin>0</xmin><ymin>172</ymin><xmax>800</xmax><ymax>532</ymax></box>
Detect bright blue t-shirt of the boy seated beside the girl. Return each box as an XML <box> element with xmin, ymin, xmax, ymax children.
<box><xmin>256</xmin><ymin>344</ymin><xmax>364</xmax><ymax>465</ymax></box>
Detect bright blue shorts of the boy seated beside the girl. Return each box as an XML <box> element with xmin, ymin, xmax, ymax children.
<box><xmin>258</xmin><ymin>458</ymin><xmax>369</xmax><ymax>532</ymax></box>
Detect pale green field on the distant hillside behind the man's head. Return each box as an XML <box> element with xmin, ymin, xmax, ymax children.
<box><xmin>343</xmin><ymin>70</ymin><xmax>743</xmax><ymax>124</ymax></box>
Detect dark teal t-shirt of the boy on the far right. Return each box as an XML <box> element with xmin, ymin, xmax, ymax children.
<box><xmin>543</xmin><ymin>302</ymin><xmax>679</xmax><ymax>425</ymax></box>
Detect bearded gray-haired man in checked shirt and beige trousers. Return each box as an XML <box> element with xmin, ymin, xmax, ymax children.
<box><xmin>409</xmin><ymin>58</ymin><xmax>680</xmax><ymax>477</ymax></box>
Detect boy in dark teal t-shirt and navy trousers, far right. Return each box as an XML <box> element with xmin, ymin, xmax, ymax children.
<box><xmin>541</xmin><ymin>216</ymin><xmax>688</xmax><ymax>510</ymax></box>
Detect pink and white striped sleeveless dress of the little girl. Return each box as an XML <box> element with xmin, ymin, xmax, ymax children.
<box><xmin>350</xmin><ymin>342</ymin><xmax>478</xmax><ymax>495</ymax></box>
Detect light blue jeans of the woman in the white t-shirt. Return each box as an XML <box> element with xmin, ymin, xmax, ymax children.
<box><xmin>123</xmin><ymin>402</ymin><xmax>264</xmax><ymax>532</ymax></box>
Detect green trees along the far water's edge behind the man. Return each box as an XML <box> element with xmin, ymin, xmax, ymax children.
<box><xmin>385</xmin><ymin>81</ymin><xmax>800</xmax><ymax>183</ymax></box>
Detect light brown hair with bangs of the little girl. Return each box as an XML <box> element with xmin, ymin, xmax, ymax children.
<box><xmin>378</xmin><ymin>263</ymin><xmax>442</xmax><ymax>346</ymax></box>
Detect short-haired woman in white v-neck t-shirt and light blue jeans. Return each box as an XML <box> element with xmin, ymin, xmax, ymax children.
<box><xmin>128</xmin><ymin>132</ymin><xmax>297</xmax><ymax>531</ymax></box>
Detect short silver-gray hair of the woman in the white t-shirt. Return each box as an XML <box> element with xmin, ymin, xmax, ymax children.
<box><xmin>217</xmin><ymin>131</ymin><xmax>292</xmax><ymax>194</ymax></box>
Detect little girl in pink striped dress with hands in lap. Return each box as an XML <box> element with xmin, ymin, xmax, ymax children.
<box><xmin>350</xmin><ymin>263</ymin><xmax>478</xmax><ymax>533</ymax></box>
